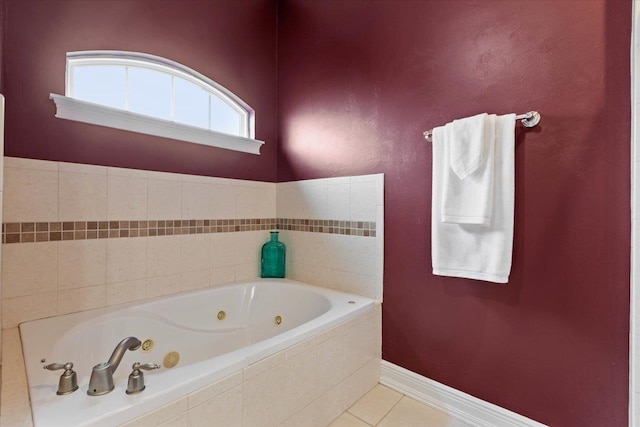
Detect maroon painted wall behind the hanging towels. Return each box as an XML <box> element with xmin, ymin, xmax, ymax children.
<box><xmin>278</xmin><ymin>0</ymin><xmax>631</xmax><ymax>427</ymax></box>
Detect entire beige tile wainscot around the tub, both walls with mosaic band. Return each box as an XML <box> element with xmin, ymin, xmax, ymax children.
<box><xmin>2</xmin><ymin>157</ymin><xmax>383</xmax><ymax>328</ymax></box>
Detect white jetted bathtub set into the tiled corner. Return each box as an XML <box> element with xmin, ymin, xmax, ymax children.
<box><xmin>20</xmin><ymin>280</ymin><xmax>375</xmax><ymax>427</ymax></box>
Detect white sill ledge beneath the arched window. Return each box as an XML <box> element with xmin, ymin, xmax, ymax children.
<box><xmin>50</xmin><ymin>93</ymin><xmax>264</xmax><ymax>154</ymax></box>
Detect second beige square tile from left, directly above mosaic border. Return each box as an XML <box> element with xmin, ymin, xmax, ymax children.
<box><xmin>58</xmin><ymin>172</ymin><xmax>107</xmax><ymax>221</ymax></box>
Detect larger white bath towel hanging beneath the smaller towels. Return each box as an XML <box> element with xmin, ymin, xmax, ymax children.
<box><xmin>431</xmin><ymin>114</ymin><xmax>515</xmax><ymax>283</ymax></box>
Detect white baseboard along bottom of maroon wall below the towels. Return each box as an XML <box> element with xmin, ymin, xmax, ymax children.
<box><xmin>380</xmin><ymin>360</ymin><xmax>545</xmax><ymax>427</ymax></box>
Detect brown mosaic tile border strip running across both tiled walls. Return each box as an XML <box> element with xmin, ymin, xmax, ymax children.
<box><xmin>2</xmin><ymin>218</ymin><xmax>376</xmax><ymax>243</ymax></box>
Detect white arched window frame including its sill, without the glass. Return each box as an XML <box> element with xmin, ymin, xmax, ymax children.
<box><xmin>50</xmin><ymin>51</ymin><xmax>264</xmax><ymax>154</ymax></box>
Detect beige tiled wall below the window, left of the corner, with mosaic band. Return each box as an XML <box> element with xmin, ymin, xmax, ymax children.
<box><xmin>2</xmin><ymin>157</ymin><xmax>276</xmax><ymax>328</ymax></box>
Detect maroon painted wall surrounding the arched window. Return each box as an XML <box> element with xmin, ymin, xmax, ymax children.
<box><xmin>2</xmin><ymin>0</ymin><xmax>277</xmax><ymax>181</ymax></box>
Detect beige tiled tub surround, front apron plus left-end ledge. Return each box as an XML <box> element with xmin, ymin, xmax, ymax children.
<box><xmin>0</xmin><ymin>304</ymin><xmax>381</xmax><ymax>427</ymax></box>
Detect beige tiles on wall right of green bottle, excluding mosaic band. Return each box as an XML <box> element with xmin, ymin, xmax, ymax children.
<box><xmin>276</xmin><ymin>174</ymin><xmax>384</xmax><ymax>301</ymax></box>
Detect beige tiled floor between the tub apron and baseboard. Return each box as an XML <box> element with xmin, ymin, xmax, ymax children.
<box><xmin>329</xmin><ymin>384</ymin><xmax>469</xmax><ymax>427</ymax></box>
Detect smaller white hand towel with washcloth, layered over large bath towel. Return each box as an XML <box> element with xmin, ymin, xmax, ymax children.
<box><xmin>442</xmin><ymin>113</ymin><xmax>496</xmax><ymax>227</ymax></box>
